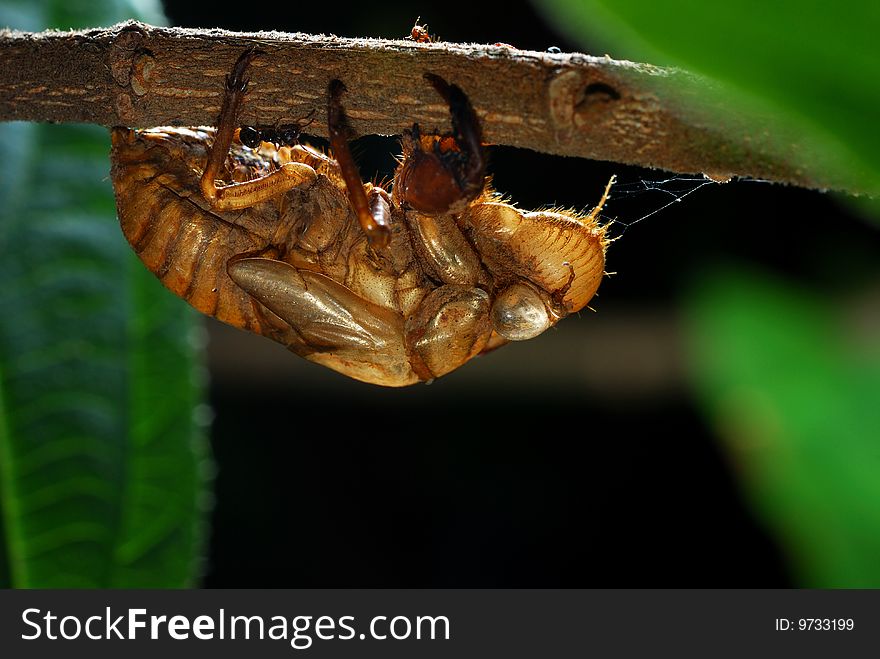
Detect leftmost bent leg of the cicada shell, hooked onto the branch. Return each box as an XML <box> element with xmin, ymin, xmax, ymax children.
<box><xmin>200</xmin><ymin>48</ymin><xmax>316</xmax><ymax>211</ymax></box>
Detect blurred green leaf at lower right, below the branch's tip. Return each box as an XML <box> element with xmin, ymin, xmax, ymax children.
<box><xmin>688</xmin><ymin>266</ymin><xmax>880</xmax><ymax>588</ymax></box>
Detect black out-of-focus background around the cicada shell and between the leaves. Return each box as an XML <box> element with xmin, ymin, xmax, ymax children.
<box><xmin>166</xmin><ymin>2</ymin><xmax>877</xmax><ymax>587</ymax></box>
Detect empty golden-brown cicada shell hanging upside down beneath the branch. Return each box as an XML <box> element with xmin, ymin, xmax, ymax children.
<box><xmin>111</xmin><ymin>51</ymin><xmax>611</xmax><ymax>386</ymax></box>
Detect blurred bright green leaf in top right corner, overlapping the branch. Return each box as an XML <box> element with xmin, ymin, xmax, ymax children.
<box><xmin>540</xmin><ymin>0</ymin><xmax>880</xmax><ymax>192</ymax></box>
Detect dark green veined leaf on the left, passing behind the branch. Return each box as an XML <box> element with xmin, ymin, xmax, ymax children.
<box><xmin>0</xmin><ymin>1</ymin><xmax>206</xmax><ymax>588</ymax></box>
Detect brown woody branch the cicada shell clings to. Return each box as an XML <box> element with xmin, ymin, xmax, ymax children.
<box><xmin>0</xmin><ymin>22</ymin><xmax>847</xmax><ymax>189</ymax></box>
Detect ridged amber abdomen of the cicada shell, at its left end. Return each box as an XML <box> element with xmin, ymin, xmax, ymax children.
<box><xmin>111</xmin><ymin>128</ymin><xmax>298</xmax><ymax>336</ymax></box>
